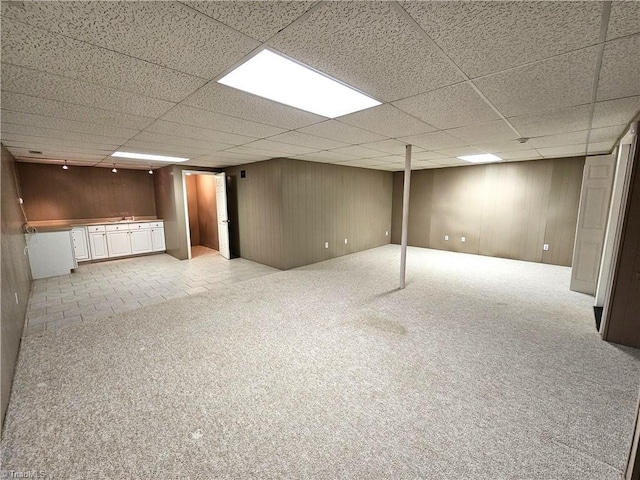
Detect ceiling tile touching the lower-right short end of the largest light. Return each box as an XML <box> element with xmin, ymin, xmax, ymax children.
<box><xmin>339</xmin><ymin>103</ymin><xmax>435</xmax><ymax>137</ymax></box>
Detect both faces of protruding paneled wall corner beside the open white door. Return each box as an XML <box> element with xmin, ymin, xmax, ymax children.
<box><xmin>227</xmin><ymin>158</ymin><xmax>393</xmax><ymax>269</ymax></box>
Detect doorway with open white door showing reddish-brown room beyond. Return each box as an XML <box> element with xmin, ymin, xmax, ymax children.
<box><xmin>182</xmin><ymin>170</ymin><xmax>229</xmax><ymax>259</ymax></box>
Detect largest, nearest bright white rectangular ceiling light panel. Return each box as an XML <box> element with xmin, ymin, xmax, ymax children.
<box><xmin>218</xmin><ymin>50</ymin><xmax>380</xmax><ymax>118</ymax></box>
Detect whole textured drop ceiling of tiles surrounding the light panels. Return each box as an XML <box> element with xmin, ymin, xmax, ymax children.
<box><xmin>1</xmin><ymin>0</ymin><xmax>640</xmax><ymax>171</ymax></box>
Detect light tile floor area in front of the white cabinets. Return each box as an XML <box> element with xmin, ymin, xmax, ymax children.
<box><xmin>24</xmin><ymin>247</ymin><xmax>279</xmax><ymax>335</ymax></box>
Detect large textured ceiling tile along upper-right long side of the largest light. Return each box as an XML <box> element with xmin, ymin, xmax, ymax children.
<box><xmin>269</xmin><ymin>2</ymin><xmax>463</xmax><ymax>101</ymax></box>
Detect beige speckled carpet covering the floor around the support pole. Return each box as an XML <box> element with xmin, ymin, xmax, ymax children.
<box><xmin>2</xmin><ymin>245</ymin><xmax>640</xmax><ymax>480</ymax></box>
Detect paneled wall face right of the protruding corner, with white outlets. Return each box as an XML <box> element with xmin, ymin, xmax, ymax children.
<box><xmin>282</xmin><ymin>159</ymin><xmax>393</xmax><ymax>268</ymax></box>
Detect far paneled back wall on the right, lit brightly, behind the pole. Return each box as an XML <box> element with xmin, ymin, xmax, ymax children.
<box><xmin>392</xmin><ymin>157</ymin><xmax>584</xmax><ymax>266</ymax></box>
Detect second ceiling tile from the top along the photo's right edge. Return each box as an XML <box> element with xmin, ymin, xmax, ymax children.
<box><xmin>598</xmin><ymin>34</ymin><xmax>640</xmax><ymax>101</ymax></box>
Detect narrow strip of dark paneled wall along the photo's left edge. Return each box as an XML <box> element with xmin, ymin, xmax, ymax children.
<box><xmin>0</xmin><ymin>146</ymin><xmax>31</xmax><ymax>428</ymax></box>
